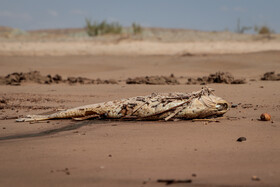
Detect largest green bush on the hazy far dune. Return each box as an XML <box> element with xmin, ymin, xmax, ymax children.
<box><xmin>86</xmin><ymin>19</ymin><xmax>122</xmax><ymax>36</ymax></box>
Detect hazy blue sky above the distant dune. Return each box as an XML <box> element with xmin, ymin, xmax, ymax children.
<box><xmin>0</xmin><ymin>0</ymin><xmax>280</xmax><ymax>33</ymax></box>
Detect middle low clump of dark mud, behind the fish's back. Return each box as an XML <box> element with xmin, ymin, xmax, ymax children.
<box><xmin>126</xmin><ymin>74</ymin><xmax>180</xmax><ymax>85</ymax></box>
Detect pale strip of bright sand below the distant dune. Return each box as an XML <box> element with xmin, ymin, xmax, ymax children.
<box><xmin>0</xmin><ymin>40</ymin><xmax>280</xmax><ymax>56</ymax></box>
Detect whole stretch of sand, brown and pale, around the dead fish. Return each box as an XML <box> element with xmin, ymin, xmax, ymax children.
<box><xmin>0</xmin><ymin>37</ymin><xmax>280</xmax><ymax>186</ymax></box>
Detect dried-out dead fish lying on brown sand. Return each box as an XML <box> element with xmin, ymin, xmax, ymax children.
<box><xmin>16</xmin><ymin>88</ymin><xmax>230</xmax><ymax>122</ymax></box>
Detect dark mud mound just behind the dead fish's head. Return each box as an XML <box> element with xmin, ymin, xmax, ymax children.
<box><xmin>186</xmin><ymin>72</ymin><xmax>246</xmax><ymax>85</ymax></box>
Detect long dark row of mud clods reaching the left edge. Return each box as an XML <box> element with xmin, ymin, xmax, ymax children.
<box><xmin>0</xmin><ymin>71</ymin><xmax>117</xmax><ymax>86</ymax></box>
